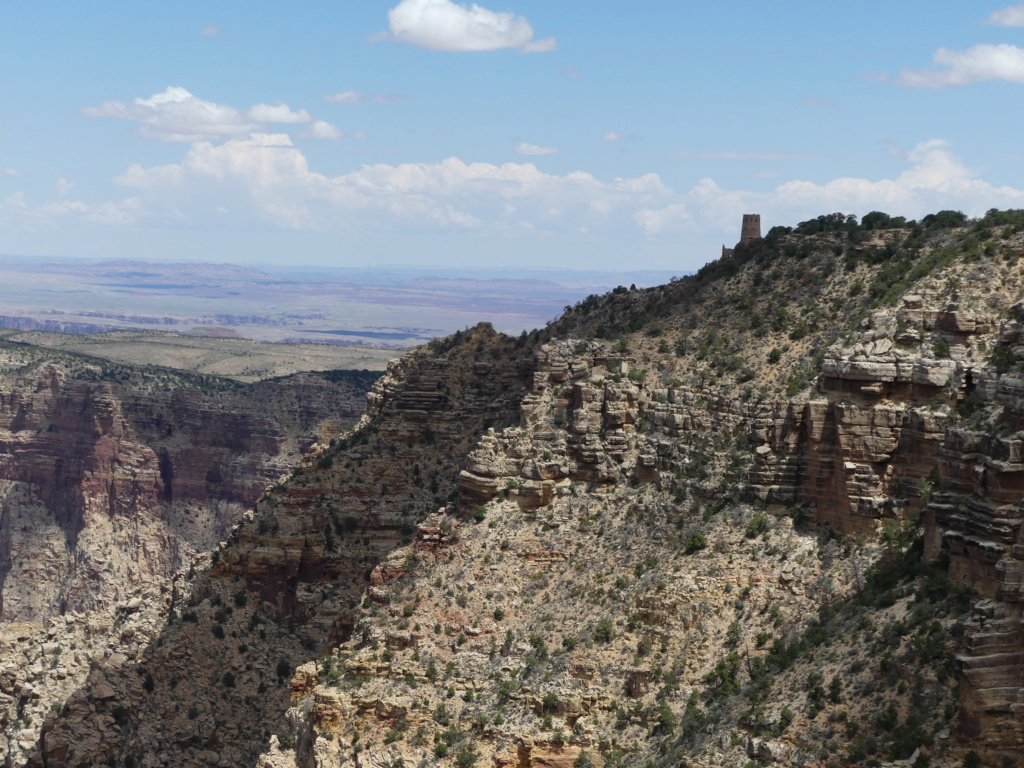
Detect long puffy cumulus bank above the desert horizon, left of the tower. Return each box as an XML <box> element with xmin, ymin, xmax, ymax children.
<box><xmin>108</xmin><ymin>134</ymin><xmax>671</xmax><ymax>233</ymax></box>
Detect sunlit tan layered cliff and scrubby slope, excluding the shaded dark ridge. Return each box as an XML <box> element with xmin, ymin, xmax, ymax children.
<box><xmin>261</xmin><ymin>217</ymin><xmax>1024</xmax><ymax>766</ymax></box>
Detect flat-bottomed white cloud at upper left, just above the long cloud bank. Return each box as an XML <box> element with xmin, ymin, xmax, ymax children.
<box><xmin>82</xmin><ymin>86</ymin><xmax>341</xmax><ymax>142</ymax></box>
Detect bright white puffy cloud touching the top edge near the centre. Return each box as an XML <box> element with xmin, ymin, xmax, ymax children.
<box><xmin>378</xmin><ymin>0</ymin><xmax>556</xmax><ymax>53</ymax></box>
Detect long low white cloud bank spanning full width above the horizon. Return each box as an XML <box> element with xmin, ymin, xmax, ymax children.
<box><xmin>9</xmin><ymin>133</ymin><xmax>1024</xmax><ymax>264</ymax></box>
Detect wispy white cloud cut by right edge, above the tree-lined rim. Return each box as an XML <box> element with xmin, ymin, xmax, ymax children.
<box><xmin>883</xmin><ymin>43</ymin><xmax>1024</xmax><ymax>88</ymax></box>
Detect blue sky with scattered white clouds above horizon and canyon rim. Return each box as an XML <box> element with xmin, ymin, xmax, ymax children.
<box><xmin>0</xmin><ymin>0</ymin><xmax>1024</xmax><ymax>271</ymax></box>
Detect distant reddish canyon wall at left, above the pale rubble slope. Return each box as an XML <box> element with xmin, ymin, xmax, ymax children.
<box><xmin>0</xmin><ymin>352</ymin><xmax>372</xmax><ymax>622</ymax></box>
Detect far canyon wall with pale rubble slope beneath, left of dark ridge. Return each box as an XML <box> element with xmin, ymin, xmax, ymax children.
<box><xmin>0</xmin><ymin>346</ymin><xmax>372</xmax><ymax>765</ymax></box>
